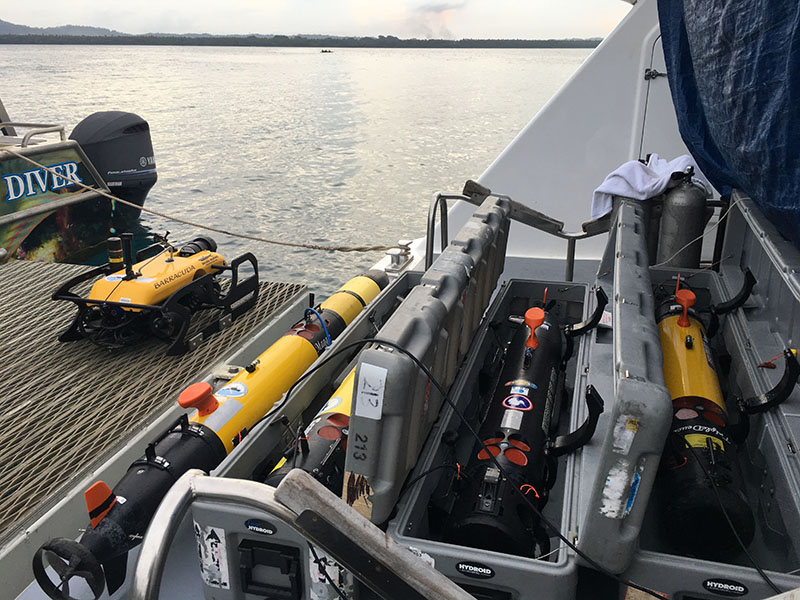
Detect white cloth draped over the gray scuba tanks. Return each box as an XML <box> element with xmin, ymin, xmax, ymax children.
<box><xmin>592</xmin><ymin>154</ymin><xmax>711</xmax><ymax>219</ymax></box>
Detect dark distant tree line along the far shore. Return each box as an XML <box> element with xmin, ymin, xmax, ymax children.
<box><xmin>0</xmin><ymin>34</ymin><xmax>601</xmax><ymax>48</ymax></box>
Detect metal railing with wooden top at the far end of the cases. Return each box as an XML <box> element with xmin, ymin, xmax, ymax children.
<box><xmin>425</xmin><ymin>180</ymin><xmax>611</xmax><ymax>281</ymax></box>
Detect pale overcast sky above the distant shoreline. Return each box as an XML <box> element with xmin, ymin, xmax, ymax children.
<box><xmin>0</xmin><ymin>0</ymin><xmax>630</xmax><ymax>39</ymax></box>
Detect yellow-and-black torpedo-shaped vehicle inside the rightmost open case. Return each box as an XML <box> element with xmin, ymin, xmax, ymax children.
<box><xmin>656</xmin><ymin>270</ymin><xmax>800</xmax><ymax>560</ymax></box>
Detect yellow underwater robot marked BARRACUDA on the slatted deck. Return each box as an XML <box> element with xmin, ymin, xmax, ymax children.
<box><xmin>53</xmin><ymin>234</ymin><xmax>258</xmax><ymax>354</ymax></box>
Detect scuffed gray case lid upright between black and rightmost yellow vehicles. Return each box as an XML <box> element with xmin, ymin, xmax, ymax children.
<box><xmin>578</xmin><ymin>198</ymin><xmax>672</xmax><ymax>573</ymax></box>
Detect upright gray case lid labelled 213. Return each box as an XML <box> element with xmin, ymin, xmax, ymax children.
<box><xmin>344</xmin><ymin>198</ymin><xmax>510</xmax><ymax>523</ymax></box>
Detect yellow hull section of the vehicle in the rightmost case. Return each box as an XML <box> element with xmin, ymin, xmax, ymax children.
<box><xmin>658</xmin><ymin>315</ymin><xmax>725</xmax><ymax>411</ymax></box>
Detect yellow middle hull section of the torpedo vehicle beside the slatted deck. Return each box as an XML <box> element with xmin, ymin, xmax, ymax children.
<box><xmin>190</xmin><ymin>335</ymin><xmax>317</xmax><ymax>453</ymax></box>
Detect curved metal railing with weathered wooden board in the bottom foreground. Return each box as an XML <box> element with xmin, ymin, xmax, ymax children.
<box><xmin>130</xmin><ymin>469</ymin><xmax>474</xmax><ymax>600</ymax></box>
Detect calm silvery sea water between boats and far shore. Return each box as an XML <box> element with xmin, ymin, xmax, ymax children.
<box><xmin>0</xmin><ymin>46</ymin><xmax>590</xmax><ymax>297</ymax></box>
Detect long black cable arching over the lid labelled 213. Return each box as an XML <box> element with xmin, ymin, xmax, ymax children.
<box><xmin>272</xmin><ymin>338</ymin><xmax>664</xmax><ymax>600</ymax></box>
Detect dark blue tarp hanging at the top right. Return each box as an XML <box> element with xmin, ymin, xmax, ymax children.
<box><xmin>658</xmin><ymin>0</ymin><xmax>800</xmax><ymax>247</ymax></box>
